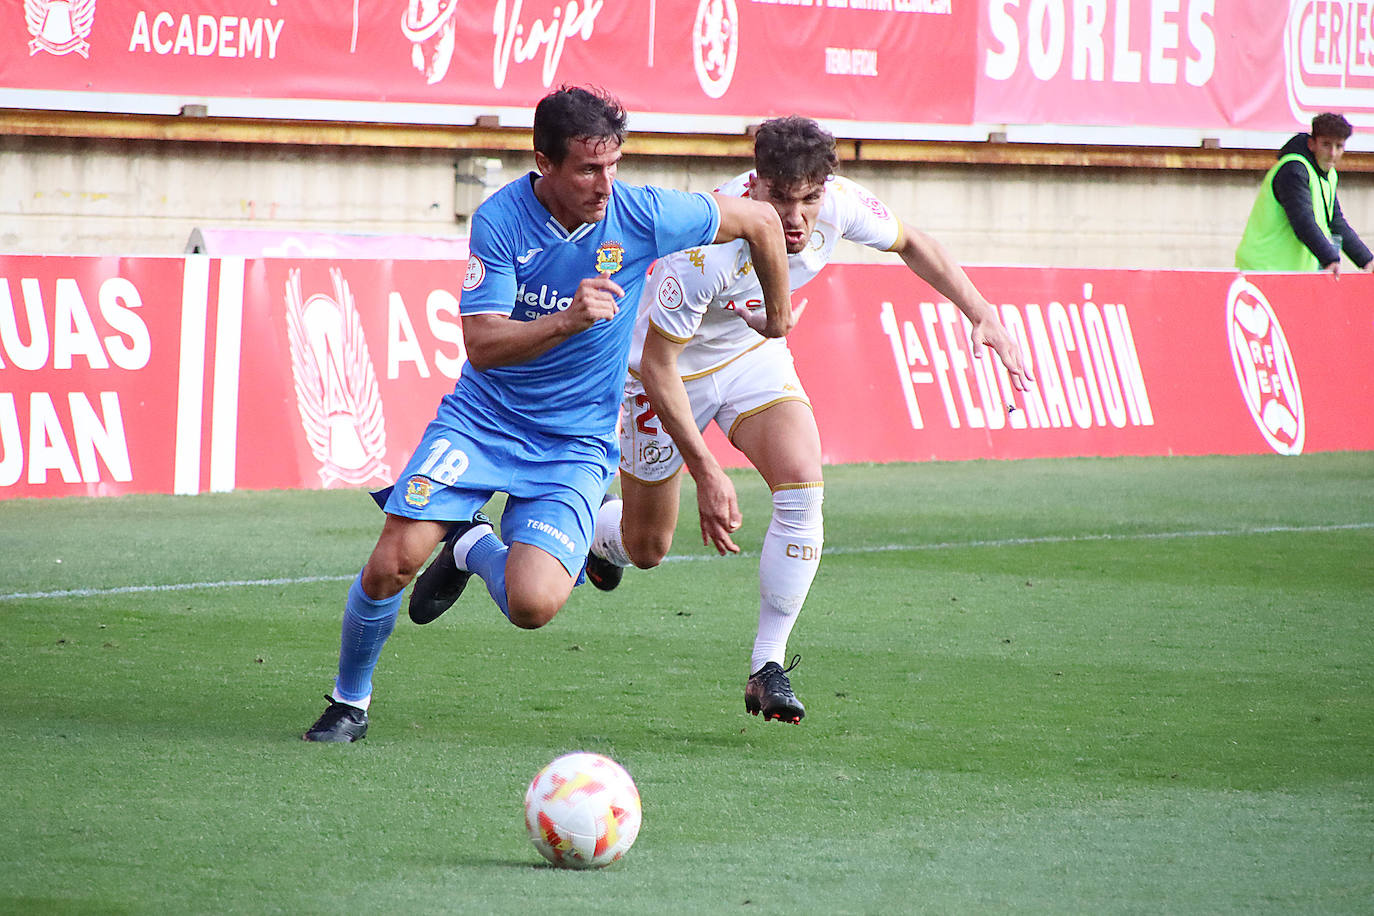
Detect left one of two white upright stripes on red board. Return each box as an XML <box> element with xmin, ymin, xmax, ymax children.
<box><xmin>172</xmin><ymin>254</ymin><xmax>210</xmax><ymax>496</ymax></box>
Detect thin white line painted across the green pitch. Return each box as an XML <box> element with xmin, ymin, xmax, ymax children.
<box><xmin>0</xmin><ymin>522</ymin><xmax>1374</xmax><ymax>602</ymax></box>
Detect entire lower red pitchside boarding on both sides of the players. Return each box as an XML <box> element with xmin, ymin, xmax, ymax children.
<box><xmin>0</xmin><ymin>255</ymin><xmax>1374</xmax><ymax>499</ymax></box>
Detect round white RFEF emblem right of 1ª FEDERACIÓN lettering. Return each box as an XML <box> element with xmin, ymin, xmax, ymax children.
<box><xmin>1226</xmin><ymin>276</ymin><xmax>1307</xmax><ymax>455</ymax></box>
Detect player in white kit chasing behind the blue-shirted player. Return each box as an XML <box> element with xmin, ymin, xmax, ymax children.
<box><xmin>587</xmin><ymin>117</ymin><xmax>1032</xmax><ymax>722</ymax></box>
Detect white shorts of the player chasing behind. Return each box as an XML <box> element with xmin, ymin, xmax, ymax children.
<box><xmin>620</xmin><ymin>341</ymin><xmax>811</xmax><ymax>483</ymax></box>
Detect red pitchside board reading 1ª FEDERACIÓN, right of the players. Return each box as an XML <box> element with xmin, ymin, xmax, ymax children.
<box><xmin>789</xmin><ymin>265</ymin><xmax>1374</xmax><ymax>463</ymax></box>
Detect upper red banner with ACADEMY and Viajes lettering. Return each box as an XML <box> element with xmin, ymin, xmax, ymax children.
<box><xmin>0</xmin><ymin>0</ymin><xmax>976</xmax><ymax>124</ymax></box>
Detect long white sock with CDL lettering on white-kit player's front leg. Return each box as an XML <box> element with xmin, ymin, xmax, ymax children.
<box><xmin>749</xmin><ymin>481</ymin><xmax>824</xmax><ymax>674</ymax></box>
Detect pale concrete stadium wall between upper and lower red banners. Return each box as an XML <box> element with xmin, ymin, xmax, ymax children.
<box><xmin>0</xmin><ymin>133</ymin><xmax>1374</xmax><ymax>269</ymax></box>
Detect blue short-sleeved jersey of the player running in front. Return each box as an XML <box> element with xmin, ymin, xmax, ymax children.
<box><xmin>453</xmin><ymin>173</ymin><xmax>720</xmax><ymax>435</ymax></box>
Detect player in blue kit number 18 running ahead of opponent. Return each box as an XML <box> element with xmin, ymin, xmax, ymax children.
<box><xmin>304</xmin><ymin>87</ymin><xmax>793</xmax><ymax>742</ymax></box>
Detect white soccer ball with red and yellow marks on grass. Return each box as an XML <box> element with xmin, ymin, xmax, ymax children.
<box><xmin>525</xmin><ymin>751</ymin><xmax>640</xmax><ymax>868</ymax></box>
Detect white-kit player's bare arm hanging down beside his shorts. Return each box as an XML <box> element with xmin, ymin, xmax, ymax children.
<box><xmin>639</xmin><ymin>325</ymin><xmax>743</xmax><ymax>555</ymax></box>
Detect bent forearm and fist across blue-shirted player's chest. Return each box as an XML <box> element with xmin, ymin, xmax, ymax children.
<box><xmin>463</xmin><ymin>273</ymin><xmax>625</xmax><ymax>369</ymax></box>
